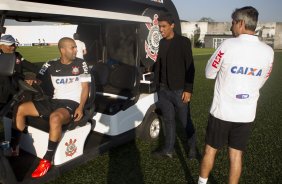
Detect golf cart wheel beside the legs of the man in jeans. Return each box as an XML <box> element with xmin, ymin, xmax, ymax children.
<box><xmin>140</xmin><ymin>112</ymin><xmax>161</xmax><ymax>141</ymax></box>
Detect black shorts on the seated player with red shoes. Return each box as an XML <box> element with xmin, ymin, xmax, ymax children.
<box><xmin>33</xmin><ymin>99</ymin><xmax>79</xmax><ymax>118</ymax></box>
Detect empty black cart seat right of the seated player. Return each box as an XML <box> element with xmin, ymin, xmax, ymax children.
<box><xmin>93</xmin><ymin>63</ymin><xmax>138</xmax><ymax>115</ymax></box>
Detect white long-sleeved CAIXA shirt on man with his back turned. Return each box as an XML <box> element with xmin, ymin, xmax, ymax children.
<box><xmin>206</xmin><ymin>34</ymin><xmax>274</xmax><ymax>122</ymax></box>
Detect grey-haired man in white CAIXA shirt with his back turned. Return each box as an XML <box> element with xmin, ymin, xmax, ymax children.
<box><xmin>198</xmin><ymin>6</ymin><xmax>274</xmax><ymax>184</ymax></box>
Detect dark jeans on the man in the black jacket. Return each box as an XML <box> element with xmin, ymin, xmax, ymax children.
<box><xmin>157</xmin><ymin>86</ymin><xmax>195</xmax><ymax>153</ymax></box>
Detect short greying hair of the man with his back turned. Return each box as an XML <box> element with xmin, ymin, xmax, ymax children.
<box><xmin>231</xmin><ymin>6</ymin><xmax>259</xmax><ymax>31</ymax></box>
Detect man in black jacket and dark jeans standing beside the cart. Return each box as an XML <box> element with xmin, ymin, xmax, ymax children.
<box><xmin>154</xmin><ymin>14</ymin><xmax>196</xmax><ymax>158</ymax></box>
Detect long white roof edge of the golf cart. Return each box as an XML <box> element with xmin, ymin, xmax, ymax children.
<box><xmin>0</xmin><ymin>0</ymin><xmax>152</xmax><ymax>23</ymax></box>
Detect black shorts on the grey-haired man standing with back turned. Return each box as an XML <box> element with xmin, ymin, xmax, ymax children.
<box><xmin>206</xmin><ymin>114</ymin><xmax>252</xmax><ymax>151</ymax></box>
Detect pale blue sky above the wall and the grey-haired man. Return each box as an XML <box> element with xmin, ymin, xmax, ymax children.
<box><xmin>172</xmin><ymin>0</ymin><xmax>282</xmax><ymax>22</ymax></box>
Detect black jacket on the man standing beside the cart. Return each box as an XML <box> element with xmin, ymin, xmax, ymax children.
<box><xmin>154</xmin><ymin>33</ymin><xmax>195</xmax><ymax>93</ymax></box>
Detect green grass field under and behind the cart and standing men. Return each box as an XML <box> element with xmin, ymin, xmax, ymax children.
<box><xmin>0</xmin><ymin>47</ymin><xmax>282</xmax><ymax>184</ymax></box>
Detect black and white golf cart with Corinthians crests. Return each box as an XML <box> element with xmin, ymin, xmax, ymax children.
<box><xmin>0</xmin><ymin>0</ymin><xmax>180</xmax><ymax>183</ymax></box>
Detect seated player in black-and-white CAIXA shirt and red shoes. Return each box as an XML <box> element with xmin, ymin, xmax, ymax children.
<box><xmin>11</xmin><ymin>37</ymin><xmax>91</xmax><ymax>178</ymax></box>
